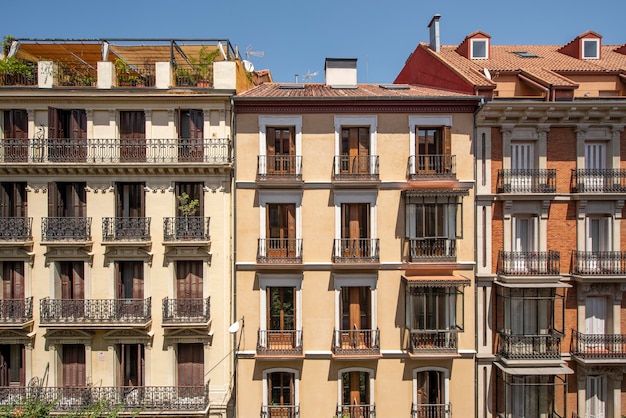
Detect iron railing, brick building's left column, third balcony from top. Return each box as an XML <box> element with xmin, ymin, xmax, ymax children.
<box><xmin>498</xmin><ymin>331</ymin><xmax>562</xmax><ymax>360</ymax></box>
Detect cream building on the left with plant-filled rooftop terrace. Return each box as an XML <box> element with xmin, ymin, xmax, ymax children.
<box><xmin>0</xmin><ymin>40</ymin><xmax>249</xmax><ymax>417</ymax></box>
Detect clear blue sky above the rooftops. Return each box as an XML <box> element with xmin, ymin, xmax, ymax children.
<box><xmin>0</xmin><ymin>0</ymin><xmax>626</xmax><ymax>83</ymax></box>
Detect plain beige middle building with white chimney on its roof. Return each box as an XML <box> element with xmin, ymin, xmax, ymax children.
<box><xmin>235</xmin><ymin>59</ymin><xmax>478</xmax><ymax>418</ymax></box>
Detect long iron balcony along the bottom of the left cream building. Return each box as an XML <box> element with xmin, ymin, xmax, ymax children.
<box><xmin>0</xmin><ymin>384</ymin><xmax>209</xmax><ymax>415</ymax></box>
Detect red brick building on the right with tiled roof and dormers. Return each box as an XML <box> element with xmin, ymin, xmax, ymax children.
<box><xmin>396</xmin><ymin>16</ymin><xmax>626</xmax><ymax>418</ymax></box>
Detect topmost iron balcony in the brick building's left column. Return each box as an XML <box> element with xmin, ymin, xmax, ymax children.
<box><xmin>496</xmin><ymin>168</ymin><xmax>556</xmax><ymax>193</ymax></box>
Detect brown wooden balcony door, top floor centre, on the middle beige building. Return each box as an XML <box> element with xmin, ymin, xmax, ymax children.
<box><xmin>340</xmin><ymin>127</ymin><xmax>370</xmax><ymax>175</ymax></box>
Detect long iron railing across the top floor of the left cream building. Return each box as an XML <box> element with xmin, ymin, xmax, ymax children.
<box><xmin>0</xmin><ymin>138</ymin><xmax>232</xmax><ymax>164</ymax></box>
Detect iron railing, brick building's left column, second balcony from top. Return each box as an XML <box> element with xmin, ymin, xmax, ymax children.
<box><xmin>497</xmin><ymin>251</ymin><xmax>561</xmax><ymax>276</ymax></box>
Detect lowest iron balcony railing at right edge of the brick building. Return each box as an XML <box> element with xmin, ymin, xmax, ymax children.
<box><xmin>570</xmin><ymin>330</ymin><xmax>626</xmax><ymax>360</ymax></box>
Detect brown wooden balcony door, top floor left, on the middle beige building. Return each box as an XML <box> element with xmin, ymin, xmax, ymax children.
<box><xmin>266</xmin><ymin>126</ymin><xmax>296</xmax><ymax>175</ymax></box>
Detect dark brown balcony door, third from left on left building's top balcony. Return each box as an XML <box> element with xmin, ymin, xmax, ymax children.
<box><xmin>120</xmin><ymin>110</ymin><xmax>146</xmax><ymax>162</ymax></box>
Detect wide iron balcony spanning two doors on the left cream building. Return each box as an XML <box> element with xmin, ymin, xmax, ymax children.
<box><xmin>40</xmin><ymin>297</ymin><xmax>152</xmax><ymax>328</ymax></box>
